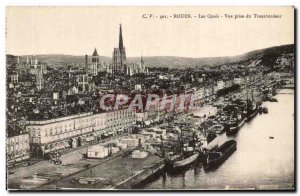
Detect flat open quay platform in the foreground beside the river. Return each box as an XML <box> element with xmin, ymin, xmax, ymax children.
<box><xmin>37</xmin><ymin>153</ymin><xmax>164</xmax><ymax>190</ymax></box>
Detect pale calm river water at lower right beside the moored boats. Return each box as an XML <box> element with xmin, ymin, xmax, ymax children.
<box><xmin>137</xmin><ymin>90</ymin><xmax>294</xmax><ymax>190</ymax></box>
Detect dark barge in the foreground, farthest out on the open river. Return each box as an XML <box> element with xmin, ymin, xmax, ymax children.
<box><xmin>205</xmin><ymin>140</ymin><xmax>236</xmax><ymax>170</ymax></box>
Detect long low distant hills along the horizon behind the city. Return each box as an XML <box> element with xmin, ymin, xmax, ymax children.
<box><xmin>6</xmin><ymin>44</ymin><xmax>294</xmax><ymax>68</ymax></box>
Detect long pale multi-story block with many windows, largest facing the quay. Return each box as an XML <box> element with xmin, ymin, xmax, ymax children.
<box><xmin>26</xmin><ymin>109</ymin><xmax>135</xmax><ymax>156</ymax></box>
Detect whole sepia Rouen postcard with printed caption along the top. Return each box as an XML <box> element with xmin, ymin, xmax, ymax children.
<box><xmin>6</xmin><ymin>6</ymin><xmax>296</xmax><ymax>191</ymax></box>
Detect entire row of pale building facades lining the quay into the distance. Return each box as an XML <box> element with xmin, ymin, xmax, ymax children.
<box><xmin>7</xmin><ymin>68</ymin><xmax>260</xmax><ymax>163</ymax></box>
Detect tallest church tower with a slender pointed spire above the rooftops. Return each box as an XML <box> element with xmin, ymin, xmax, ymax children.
<box><xmin>112</xmin><ymin>24</ymin><xmax>126</xmax><ymax>75</ymax></box>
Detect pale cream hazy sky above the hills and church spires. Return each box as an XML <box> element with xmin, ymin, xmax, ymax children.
<box><xmin>6</xmin><ymin>7</ymin><xmax>294</xmax><ymax>57</ymax></box>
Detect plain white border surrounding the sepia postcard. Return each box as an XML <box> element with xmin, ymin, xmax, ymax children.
<box><xmin>0</xmin><ymin>0</ymin><xmax>300</xmax><ymax>196</ymax></box>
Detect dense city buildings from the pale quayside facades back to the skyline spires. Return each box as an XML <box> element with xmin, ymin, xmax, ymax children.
<box><xmin>7</xmin><ymin>25</ymin><xmax>268</xmax><ymax>166</ymax></box>
